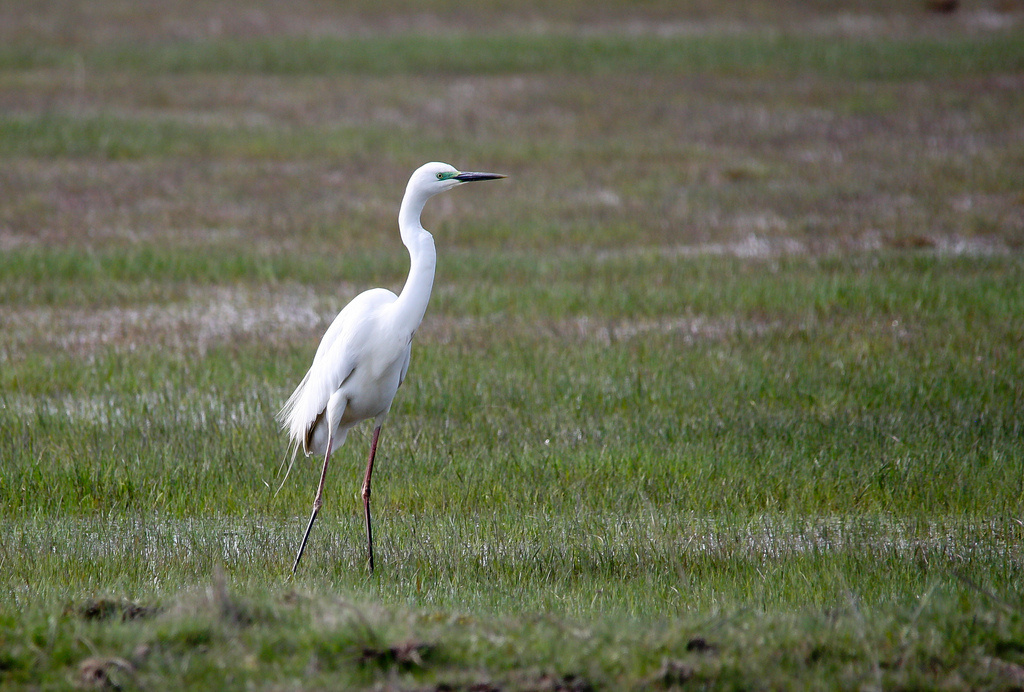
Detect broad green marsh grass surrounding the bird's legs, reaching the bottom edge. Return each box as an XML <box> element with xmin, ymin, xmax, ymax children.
<box><xmin>0</xmin><ymin>249</ymin><xmax>1024</xmax><ymax>688</ymax></box>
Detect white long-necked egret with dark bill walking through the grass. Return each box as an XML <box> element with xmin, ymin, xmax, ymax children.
<box><xmin>278</xmin><ymin>162</ymin><xmax>505</xmax><ymax>574</ymax></box>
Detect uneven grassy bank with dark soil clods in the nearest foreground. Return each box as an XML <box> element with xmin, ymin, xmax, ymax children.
<box><xmin>2</xmin><ymin>569</ymin><xmax>1021</xmax><ymax>689</ymax></box>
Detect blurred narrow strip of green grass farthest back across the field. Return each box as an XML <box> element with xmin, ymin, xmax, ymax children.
<box><xmin>6</xmin><ymin>34</ymin><xmax>1024</xmax><ymax>80</ymax></box>
